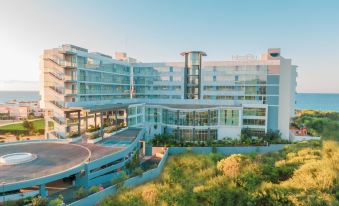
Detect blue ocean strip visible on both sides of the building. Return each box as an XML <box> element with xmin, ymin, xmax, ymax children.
<box><xmin>0</xmin><ymin>91</ymin><xmax>339</xmax><ymax>112</ymax></box>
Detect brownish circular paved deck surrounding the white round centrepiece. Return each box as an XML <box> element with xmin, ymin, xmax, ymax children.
<box><xmin>0</xmin><ymin>143</ymin><xmax>90</xmax><ymax>184</ymax></box>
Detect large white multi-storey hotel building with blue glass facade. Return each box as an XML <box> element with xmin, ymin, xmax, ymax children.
<box><xmin>41</xmin><ymin>45</ymin><xmax>296</xmax><ymax>141</ymax></box>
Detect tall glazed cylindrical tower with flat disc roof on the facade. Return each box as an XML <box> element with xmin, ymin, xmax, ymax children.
<box><xmin>181</xmin><ymin>51</ymin><xmax>206</xmax><ymax>99</ymax></box>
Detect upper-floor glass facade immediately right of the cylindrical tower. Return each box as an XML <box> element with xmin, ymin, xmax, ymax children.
<box><xmin>202</xmin><ymin>65</ymin><xmax>268</xmax><ymax>104</ymax></box>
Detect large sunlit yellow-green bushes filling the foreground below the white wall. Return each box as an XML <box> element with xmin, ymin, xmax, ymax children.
<box><xmin>100</xmin><ymin>140</ymin><xmax>339</xmax><ymax>206</ymax></box>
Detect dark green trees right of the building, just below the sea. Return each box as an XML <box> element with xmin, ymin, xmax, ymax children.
<box><xmin>291</xmin><ymin>110</ymin><xmax>339</xmax><ymax>140</ymax></box>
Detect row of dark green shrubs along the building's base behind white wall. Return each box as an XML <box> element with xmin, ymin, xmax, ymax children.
<box><xmin>151</xmin><ymin>128</ymin><xmax>288</xmax><ymax>147</ymax></box>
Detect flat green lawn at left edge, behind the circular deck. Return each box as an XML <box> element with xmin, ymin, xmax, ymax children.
<box><xmin>0</xmin><ymin>119</ymin><xmax>45</xmax><ymax>135</ymax></box>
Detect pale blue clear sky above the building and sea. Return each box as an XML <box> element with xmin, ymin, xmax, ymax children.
<box><xmin>0</xmin><ymin>0</ymin><xmax>339</xmax><ymax>93</ymax></box>
